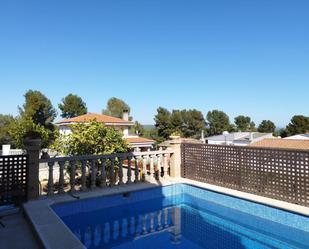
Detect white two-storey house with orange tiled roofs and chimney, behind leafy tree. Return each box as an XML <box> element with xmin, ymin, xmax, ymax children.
<box><xmin>56</xmin><ymin>112</ymin><xmax>155</xmax><ymax>151</ymax></box>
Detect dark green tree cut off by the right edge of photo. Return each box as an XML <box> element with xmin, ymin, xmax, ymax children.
<box><xmin>283</xmin><ymin>115</ymin><xmax>309</xmax><ymax>136</ymax></box>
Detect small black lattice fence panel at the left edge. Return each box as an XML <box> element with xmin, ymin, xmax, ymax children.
<box><xmin>0</xmin><ymin>155</ymin><xmax>28</xmax><ymax>206</ymax></box>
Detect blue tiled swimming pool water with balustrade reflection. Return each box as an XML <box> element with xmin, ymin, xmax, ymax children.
<box><xmin>52</xmin><ymin>184</ymin><xmax>309</xmax><ymax>249</ymax></box>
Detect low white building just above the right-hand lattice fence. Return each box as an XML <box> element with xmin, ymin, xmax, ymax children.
<box><xmin>205</xmin><ymin>132</ymin><xmax>273</xmax><ymax>146</ymax></box>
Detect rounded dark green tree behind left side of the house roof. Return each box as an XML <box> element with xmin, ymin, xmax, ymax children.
<box><xmin>58</xmin><ymin>94</ymin><xmax>87</xmax><ymax>118</ymax></box>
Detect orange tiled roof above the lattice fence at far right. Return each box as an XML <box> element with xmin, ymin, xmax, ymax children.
<box><xmin>250</xmin><ymin>138</ymin><xmax>309</xmax><ymax>150</ymax></box>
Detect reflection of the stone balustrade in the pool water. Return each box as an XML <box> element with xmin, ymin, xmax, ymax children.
<box><xmin>73</xmin><ymin>207</ymin><xmax>181</xmax><ymax>247</ymax></box>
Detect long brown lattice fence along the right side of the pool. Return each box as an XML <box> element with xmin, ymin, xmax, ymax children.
<box><xmin>181</xmin><ymin>143</ymin><xmax>309</xmax><ymax>206</ymax></box>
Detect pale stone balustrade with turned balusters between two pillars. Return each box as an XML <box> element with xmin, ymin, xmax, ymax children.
<box><xmin>39</xmin><ymin>149</ymin><xmax>173</xmax><ymax>195</ymax></box>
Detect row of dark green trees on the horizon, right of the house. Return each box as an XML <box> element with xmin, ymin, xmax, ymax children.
<box><xmin>154</xmin><ymin>107</ymin><xmax>309</xmax><ymax>140</ymax></box>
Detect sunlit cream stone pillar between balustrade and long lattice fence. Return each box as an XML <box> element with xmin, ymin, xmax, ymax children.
<box><xmin>168</xmin><ymin>139</ymin><xmax>181</xmax><ymax>177</ymax></box>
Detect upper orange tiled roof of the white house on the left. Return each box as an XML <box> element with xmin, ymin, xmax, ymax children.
<box><xmin>56</xmin><ymin>113</ymin><xmax>134</xmax><ymax>125</ymax></box>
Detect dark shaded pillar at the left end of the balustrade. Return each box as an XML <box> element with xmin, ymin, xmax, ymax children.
<box><xmin>24</xmin><ymin>138</ymin><xmax>41</xmax><ymax>201</ymax></box>
